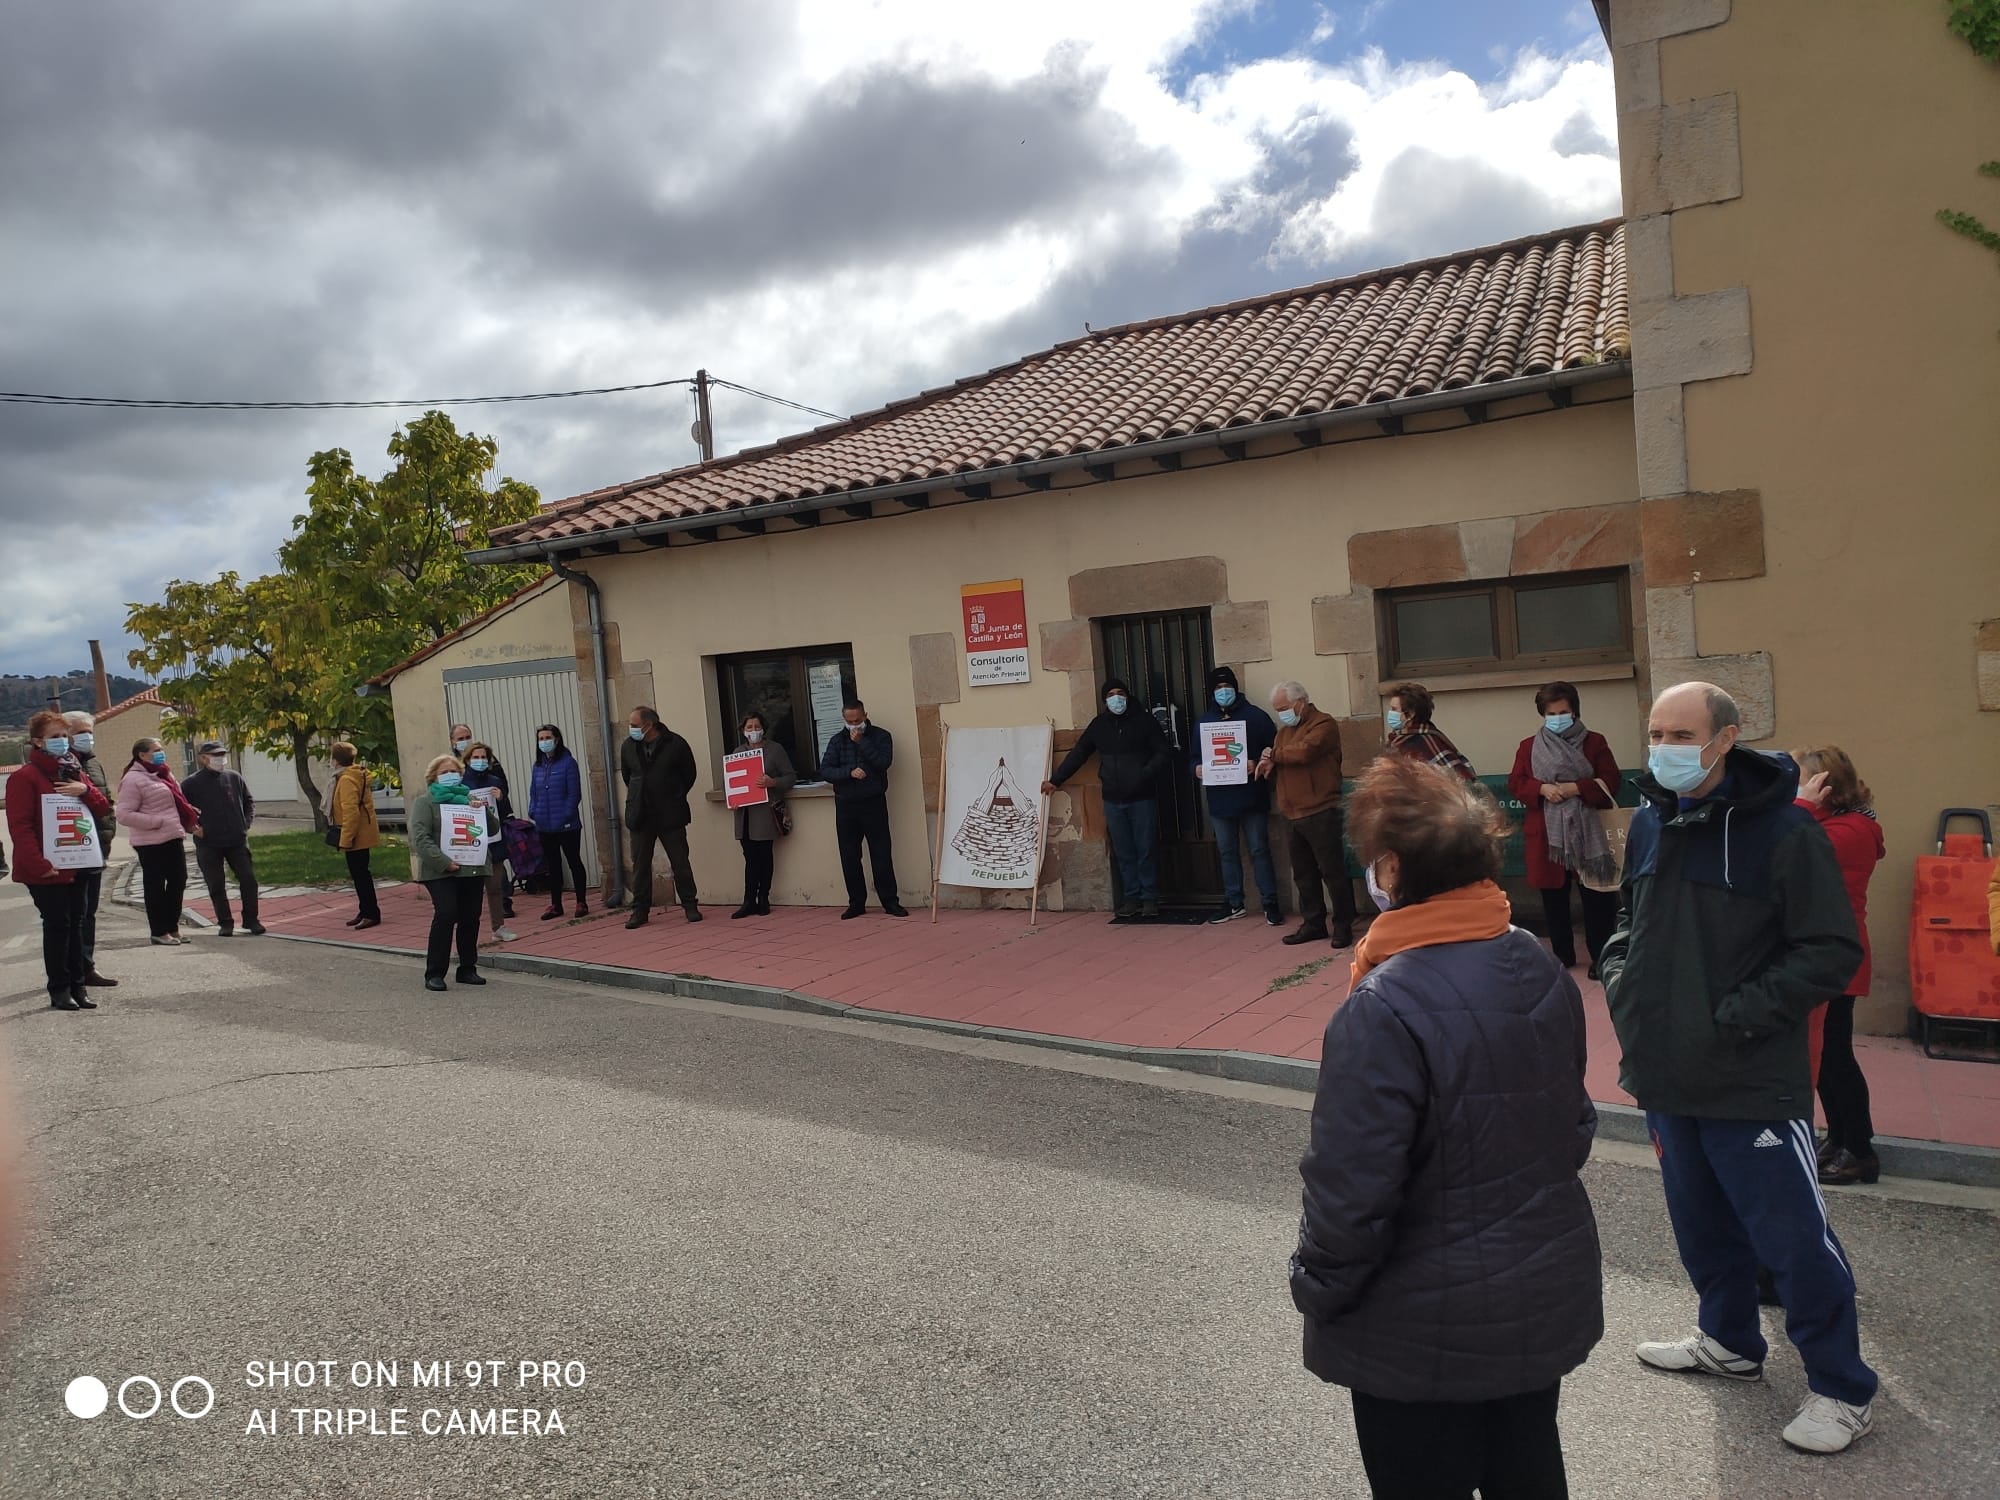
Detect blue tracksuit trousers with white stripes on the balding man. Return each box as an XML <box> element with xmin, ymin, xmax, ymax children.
<box><xmin>1646</xmin><ymin>1110</ymin><xmax>1876</xmax><ymax>1406</ymax></box>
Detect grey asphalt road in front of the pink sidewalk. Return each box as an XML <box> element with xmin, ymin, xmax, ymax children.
<box><xmin>0</xmin><ymin>884</ymin><xmax>2000</xmax><ymax>1500</ymax></box>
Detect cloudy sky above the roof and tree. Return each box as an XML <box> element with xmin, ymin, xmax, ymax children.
<box><xmin>0</xmin><ymin>0</ymin><xmax>1618</xmax><ymax>672</ymax></box>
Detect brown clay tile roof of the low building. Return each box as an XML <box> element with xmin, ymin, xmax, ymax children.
<box><xmin>492</xmin><ymin>222</ymin><xmax>1630</xmax><ymax>548</ymax></box>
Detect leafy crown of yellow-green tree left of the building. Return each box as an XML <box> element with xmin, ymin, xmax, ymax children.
<box><xmin>126</xmin><ymin>412</ymin><xmax>540</xmax><ymax>820</ymax></box>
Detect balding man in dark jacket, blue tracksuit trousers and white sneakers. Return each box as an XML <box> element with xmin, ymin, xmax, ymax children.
<box><xmin>1600</xmin><ymin>682</ymin><xmax>1876</xmax><ymax>1454</ymax></box>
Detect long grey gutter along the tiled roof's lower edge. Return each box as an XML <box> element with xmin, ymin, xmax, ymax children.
<box><xmin>466</xmin><ymin>360</ymin><xmax>1632</xmax><ymax>578</ymax></box>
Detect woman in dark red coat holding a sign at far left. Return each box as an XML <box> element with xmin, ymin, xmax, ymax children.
<box><xmin>6</xmin><ymin>710</ymin><xmax>112</xmax><ymax>1010</ymax></box>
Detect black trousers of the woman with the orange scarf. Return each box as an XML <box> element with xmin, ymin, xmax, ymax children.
<box><xmin>1354</xmin><ymin>1382</ymin><xmax>1570</xmax><ymax>1500</ymax></box>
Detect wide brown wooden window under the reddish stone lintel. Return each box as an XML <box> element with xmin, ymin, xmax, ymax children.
<box><xmin>1380</xmin><ymin>570</ymin><xmax>1632</xmax><ymax>678</ymax></box>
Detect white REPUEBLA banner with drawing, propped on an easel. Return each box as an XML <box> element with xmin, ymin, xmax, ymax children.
<box><xmin>938</xmin><ymin>724</ymin><xmax>1048</xmax><ymax>890</ymax></box>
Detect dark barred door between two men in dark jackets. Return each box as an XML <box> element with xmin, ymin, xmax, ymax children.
<box><xmin>1098</xmin><ymin>610</ymin><xmax>1222</xmax><ymax>906</ymax></box>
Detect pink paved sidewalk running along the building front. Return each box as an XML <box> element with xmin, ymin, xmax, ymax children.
<box><xmin>190</xmin><ymin>884</ymin><xmax>2000</xmax><ymax>1148</ymax></box>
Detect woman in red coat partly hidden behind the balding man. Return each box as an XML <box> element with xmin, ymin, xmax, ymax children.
<box><xmin>1794</xmin><ymin>744</ymin><xmax>1886</xmax><ymax>1186</ymax></box>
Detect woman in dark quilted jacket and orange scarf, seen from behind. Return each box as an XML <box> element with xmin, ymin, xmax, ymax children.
<box><xmin>1290</xmin><ymin>756</ymin><xmax>1604</xmax><ymax>1500</ymax></box>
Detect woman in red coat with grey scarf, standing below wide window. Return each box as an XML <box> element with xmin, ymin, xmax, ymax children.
<box><xmin>1506</xmin><ymin>682</ymin><xmax>1624</xmax><ymax>978</ymax></box>
